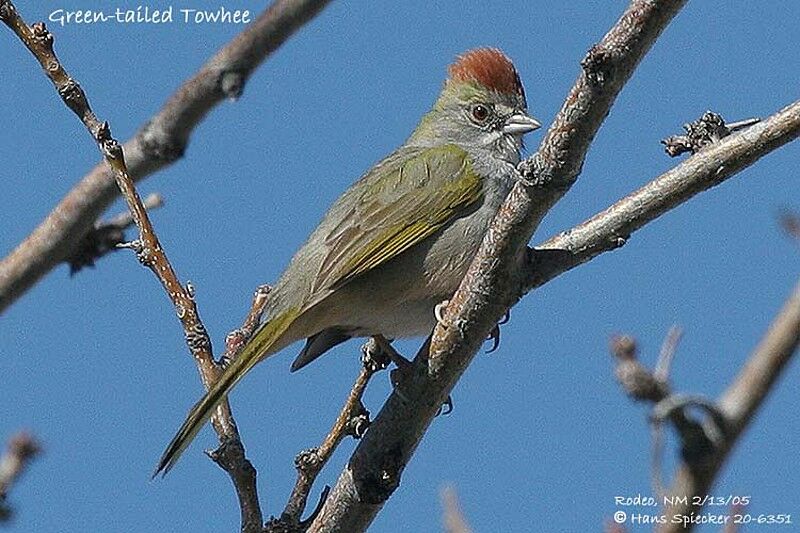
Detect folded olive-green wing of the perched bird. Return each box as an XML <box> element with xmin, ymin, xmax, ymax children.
<box><xmin>312</xmin><ymin>144</ymin><xmax>483</xmax><ymax>294</ymax></box>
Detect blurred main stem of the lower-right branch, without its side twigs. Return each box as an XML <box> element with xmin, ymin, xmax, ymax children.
<box><xmin>659</xmin><ymin>283</ymin><xmax>800</xmax><ymax>533</ymax></box>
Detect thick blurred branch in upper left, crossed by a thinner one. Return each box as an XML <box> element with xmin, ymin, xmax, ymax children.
<box><xmin>0</xmin><ymin>0</ymin><xmax>330</xmax><ymax>313</ymax></box>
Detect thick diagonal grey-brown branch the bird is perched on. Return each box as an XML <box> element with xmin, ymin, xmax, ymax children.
<box><xmin>309</xmin><ymin>0</ymin><xmax>684</xmax><ymax>532</ymax></box>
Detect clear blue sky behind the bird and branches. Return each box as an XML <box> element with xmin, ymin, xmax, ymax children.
<box><xmin>0</xmin><ymin>0</ymin><xmax>800</xmax><ymax>532</ymax></box>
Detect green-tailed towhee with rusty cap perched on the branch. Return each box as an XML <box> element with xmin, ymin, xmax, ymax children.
<box><xmin>153</xmin><ymin>48</ymin><xmax>540</xmax><ymax>476</ymax></box>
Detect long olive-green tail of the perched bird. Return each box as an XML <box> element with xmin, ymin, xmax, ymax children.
<box><xmin>153</xmin><ymin>309</ymin><xmax>300</xmax><ymax>477</ymax></box>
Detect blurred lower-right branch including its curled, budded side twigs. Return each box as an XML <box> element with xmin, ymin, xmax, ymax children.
<box><xmin>612</xmin><ymin>283</ymin><xmax>800</xmax><ymax>533</ymax></box>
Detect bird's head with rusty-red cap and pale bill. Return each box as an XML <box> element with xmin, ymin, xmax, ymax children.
<box><xmin>410</xmin><ymin>48</ymin><xmax>540</xmax><ymax>163</ymax></box>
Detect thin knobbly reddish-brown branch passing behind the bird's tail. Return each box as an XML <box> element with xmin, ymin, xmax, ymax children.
<box><xmin>0</xmin><ymin>0</ymin><xmax>276</xmax><ymax>532</ymax></box>
